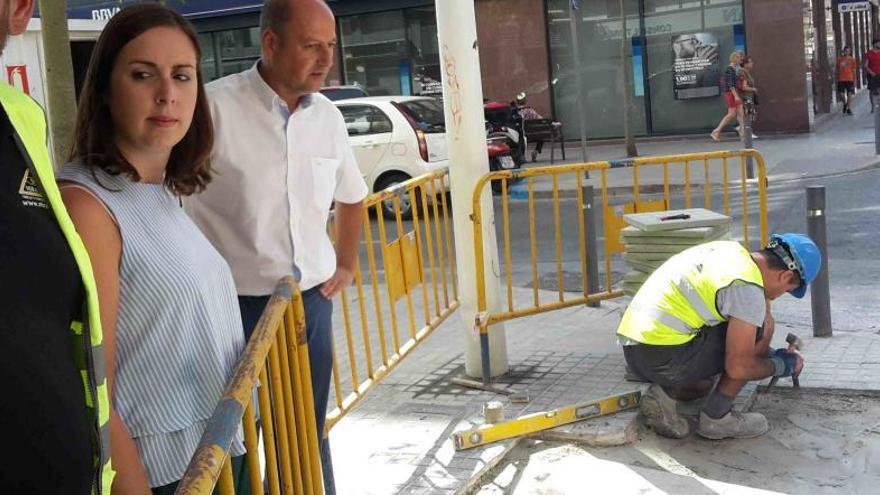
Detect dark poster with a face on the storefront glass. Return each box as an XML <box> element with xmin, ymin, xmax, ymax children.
<box><xmin>672</xmin><ymin>33</ymin><xmax>721</xmax><ymax>100</ymax></box>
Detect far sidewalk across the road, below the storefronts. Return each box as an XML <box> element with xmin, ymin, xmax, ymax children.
<box><xmin>513</xmin><ymin>91</ymin><xmax>880</xmax><ymax>199</ymax></box>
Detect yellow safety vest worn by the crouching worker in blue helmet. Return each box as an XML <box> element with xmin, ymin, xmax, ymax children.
<box><xmin>617</xmin><ymin>241</ymin><xmax>764</xmax><ymax>345</ymax></box>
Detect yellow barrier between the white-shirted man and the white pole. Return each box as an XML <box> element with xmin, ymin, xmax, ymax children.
<box><xmin>325</xmin><ymin>169</ymin><xmax>458</xmax><ymax>431</ymax></box>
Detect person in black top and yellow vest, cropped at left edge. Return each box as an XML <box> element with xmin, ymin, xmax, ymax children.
<box><xmin>0</xmin><ymin>0</ymin><xmax>113</xmax><ymax>495</ymax></box>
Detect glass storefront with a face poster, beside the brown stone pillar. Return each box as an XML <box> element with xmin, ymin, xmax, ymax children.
<box><xmin>547</xmin><ymin>0</ymin><xmax>745</xmax><ymax>139</ymax></box>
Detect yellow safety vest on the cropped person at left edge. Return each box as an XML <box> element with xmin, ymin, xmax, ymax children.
<box><xmin>0</xmin><ymin>83</ymin><xmax>114</xmax><ymax>495</ymax></box>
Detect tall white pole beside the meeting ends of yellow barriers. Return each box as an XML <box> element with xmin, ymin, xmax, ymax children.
<box><xmin>436</xmin><ymin>0</ymin><xmax>507</xmax><ymax>377</ymax></box>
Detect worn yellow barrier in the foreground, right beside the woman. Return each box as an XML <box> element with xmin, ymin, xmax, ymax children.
<box><xmin>176</xmin><ymin>277</ymin><xmax>324</xmax><ymax>495</ymax></box>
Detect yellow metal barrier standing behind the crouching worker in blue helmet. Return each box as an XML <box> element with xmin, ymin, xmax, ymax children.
<box><xmin>471</xmin><ymin>149</ymin><xmax>768</xmax><ymax>383</ymax></box>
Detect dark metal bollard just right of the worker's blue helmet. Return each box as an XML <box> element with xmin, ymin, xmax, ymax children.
<box><xmin>807</xmin><ymin>186</ymin><xmax>831</xmax><ymax>337</ymax></box>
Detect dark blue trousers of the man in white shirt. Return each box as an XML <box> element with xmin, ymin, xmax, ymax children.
<box><xmin>238</xmin><ymin>286</ymin><xmax>336</xmax><ymax>495</ymax></box>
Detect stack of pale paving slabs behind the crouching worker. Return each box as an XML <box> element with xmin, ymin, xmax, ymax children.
<box><xmin>620</xmin><ymin>208</ymin><xmax>731</xmax><ymax>296</ymax></box>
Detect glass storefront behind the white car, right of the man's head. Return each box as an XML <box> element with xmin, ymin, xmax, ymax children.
<box><xmin>339</xmin><ymin>7</ymin><xmax>442</xmax><ymax>96</ymax></box>
